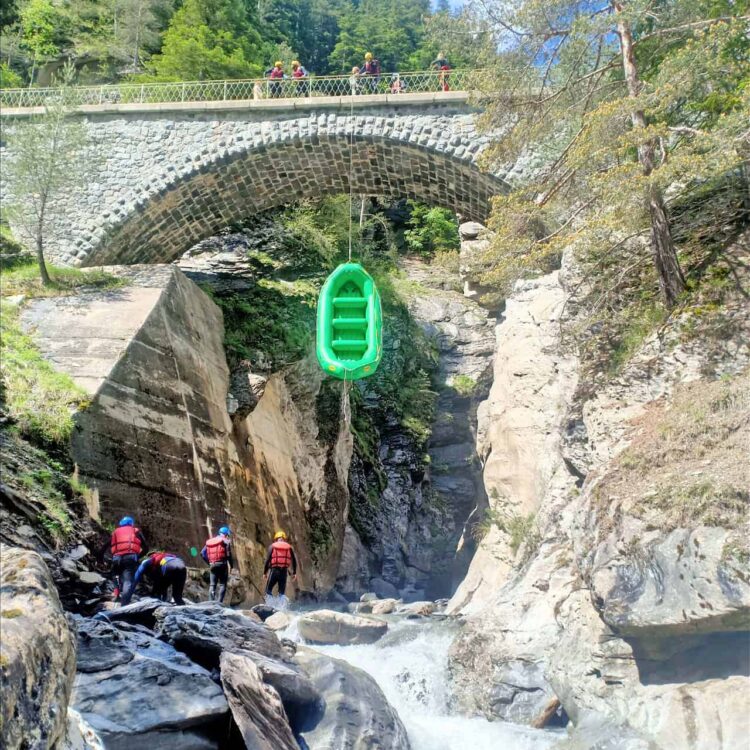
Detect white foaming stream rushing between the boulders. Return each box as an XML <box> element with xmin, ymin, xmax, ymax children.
<box><xmin>284</xmin><ymin>613</ymin><xmax>565</xmax><ymax>750</ymax></box>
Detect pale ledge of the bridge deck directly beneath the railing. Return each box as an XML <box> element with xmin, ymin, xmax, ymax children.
<box><xmin>0</xmin><ymin>91</ymin><xmax>469</xmax><ymax>117</ymax></box>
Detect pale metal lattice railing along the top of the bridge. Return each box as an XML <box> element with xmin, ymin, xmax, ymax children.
<box><xmin>0</xmin><ymin>70</ymin><xmax>475</xmax><ymax>108</ymax></box>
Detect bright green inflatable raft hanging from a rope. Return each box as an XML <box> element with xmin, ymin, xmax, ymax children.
<box><xmin>317</xmin><ymin>263</ymin><xmax>383</xmax><ymax>380</ymax></box>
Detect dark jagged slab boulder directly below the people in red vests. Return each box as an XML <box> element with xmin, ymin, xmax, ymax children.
<box><xmin>156</xmin><ymin>602</ymin><xmax>282</xmax><ymax>669</ymax></box>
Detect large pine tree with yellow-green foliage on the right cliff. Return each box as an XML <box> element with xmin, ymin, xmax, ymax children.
<box><xmin>472</xmin><ymin>0</ymin><xmax>748</xmax><ymax>307</ymax></box>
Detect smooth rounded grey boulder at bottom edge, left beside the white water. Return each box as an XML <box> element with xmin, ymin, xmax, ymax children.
<box><xmin>296</xmin><ymin>647</ymin><xmax>410</xmax><ymax>750</ymax></box>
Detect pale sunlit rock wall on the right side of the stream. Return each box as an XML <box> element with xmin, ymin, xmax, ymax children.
<box><xmin>451</xmin><ymin>235</ymin><xmax>750</xmax><ymax>750</ymax></box>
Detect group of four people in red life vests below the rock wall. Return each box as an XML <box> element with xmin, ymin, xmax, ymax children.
<box><xmin>106</xmin><ymin>516</ymin><xmax>297</xmax><ymax>606</ymax></box>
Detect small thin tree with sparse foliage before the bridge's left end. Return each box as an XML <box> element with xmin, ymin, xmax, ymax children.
<box><xmin>3</xmin><ymin>64</ymin><xmax>95</xmax><ymax>285</ymax></box>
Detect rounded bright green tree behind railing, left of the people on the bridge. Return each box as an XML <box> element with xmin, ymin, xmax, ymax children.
<box><xmin>148</xmin><ymin>0</ymin><xmax>266</xmax><ymax>81</ymax></box>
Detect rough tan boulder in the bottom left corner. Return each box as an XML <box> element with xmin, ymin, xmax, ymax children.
<box><xmin>0</xmin><ymin>545</ymin><xmax>75</xmax><ymax>750</ymax></box>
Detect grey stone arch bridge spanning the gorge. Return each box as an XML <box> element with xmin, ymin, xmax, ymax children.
<box><xmin>3</xmin><ymin>92</ymin><xmax>514</xmax><ymax>266</ymax></box>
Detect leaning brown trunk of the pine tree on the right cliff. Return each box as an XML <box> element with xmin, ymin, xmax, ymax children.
<box><xmin>612</xmin><ymin>0</ymin><xmax>685</xmax><ymax>307</ymax></box>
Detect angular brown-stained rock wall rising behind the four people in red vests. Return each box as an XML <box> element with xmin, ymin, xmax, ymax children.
<box><xmin>22</xmin><ymin>266</ymin><xmax>351</xmax><ymax>598</ymax></box>
